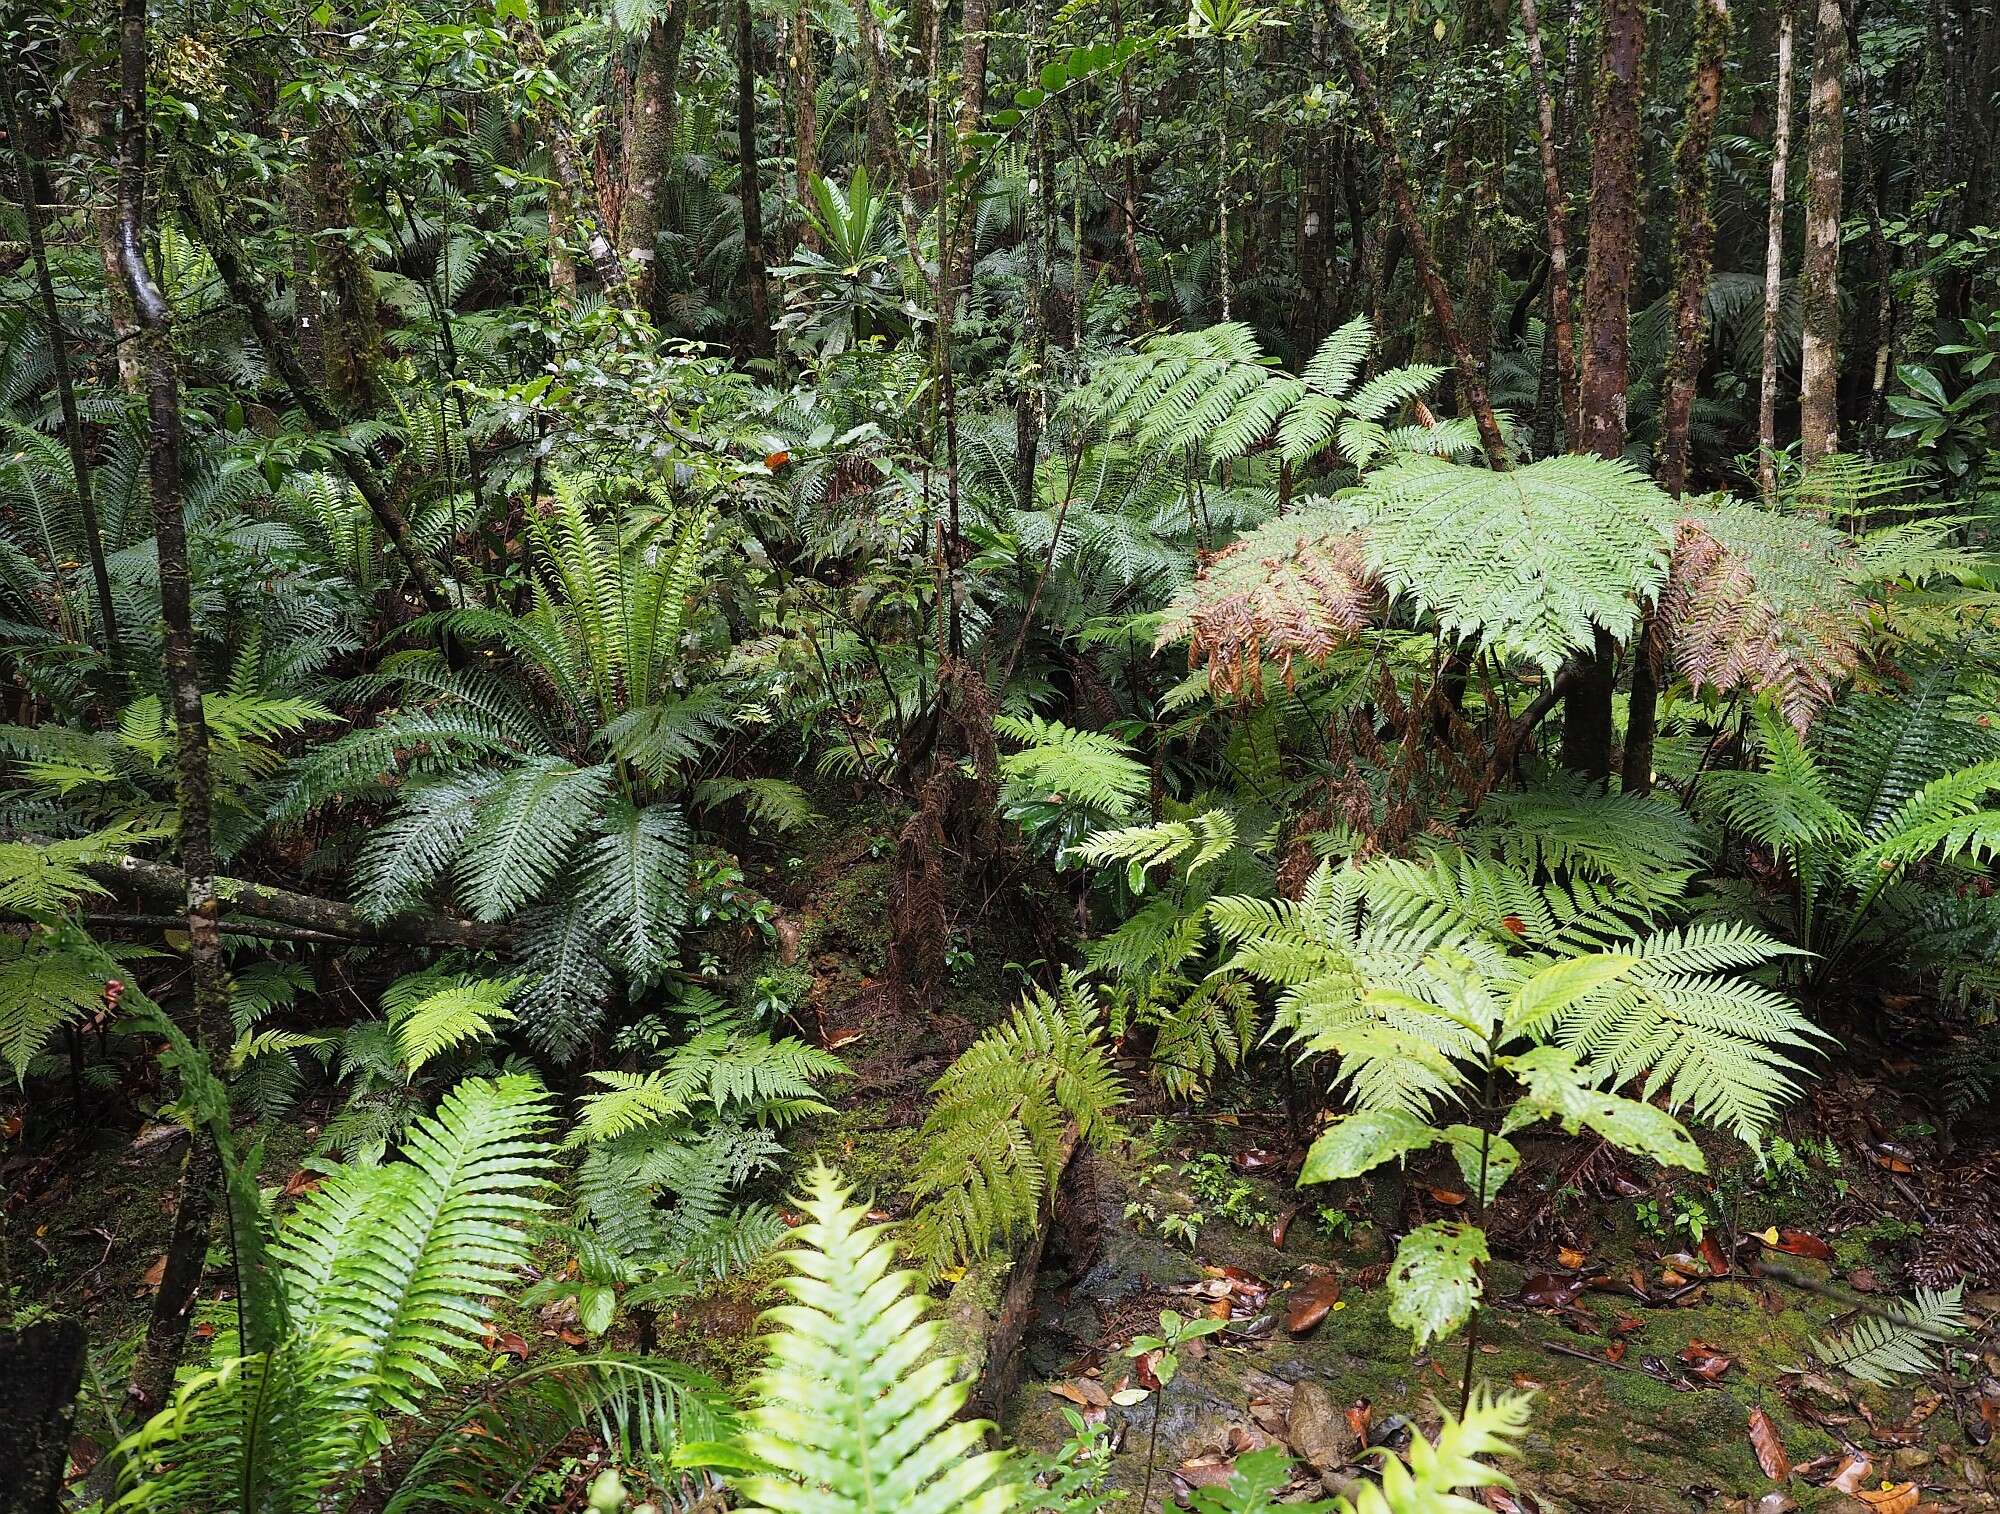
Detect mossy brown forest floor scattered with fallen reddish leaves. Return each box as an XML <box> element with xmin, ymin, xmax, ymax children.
<box><xmin>11</xmin><ymin>804</ymin><xmax>2000</xmax><ymax>1514</ymax></box>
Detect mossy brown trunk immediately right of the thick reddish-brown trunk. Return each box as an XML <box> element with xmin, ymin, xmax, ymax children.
<box><xmin>1622</xmin><ymin>0</ymin><xmax>1730</xmax><ymax>794</ymax></box>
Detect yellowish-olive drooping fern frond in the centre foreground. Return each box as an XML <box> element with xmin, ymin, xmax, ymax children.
<box><xmin>908</xmin><ymin>974</ymin><xmax>1124</xmax><ymax>1268</ymax></box>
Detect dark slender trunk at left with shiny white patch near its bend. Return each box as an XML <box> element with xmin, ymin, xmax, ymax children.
<box><xmin>118</xmin><ymin>0</ymin><xmax>230</xmax><ymax>1412</ymax></box>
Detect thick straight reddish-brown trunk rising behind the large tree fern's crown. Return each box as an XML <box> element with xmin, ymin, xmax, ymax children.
<box><xmin>1562</xmin><ymin>0</ymin><xmax>1646</xmax><ymax>778</ymax></box>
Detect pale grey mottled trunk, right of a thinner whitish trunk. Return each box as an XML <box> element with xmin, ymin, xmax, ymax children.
<box><xmin>1798</xmin><ymin>0</ymin><xmax>1848</xmax><ymax>468</ymax></box>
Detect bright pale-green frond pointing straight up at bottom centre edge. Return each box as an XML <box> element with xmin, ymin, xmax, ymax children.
<box><xmin>736</xmin><ymin>1168</ymin><xmax>1022</xmax><ymax>1514</ymax></box>
